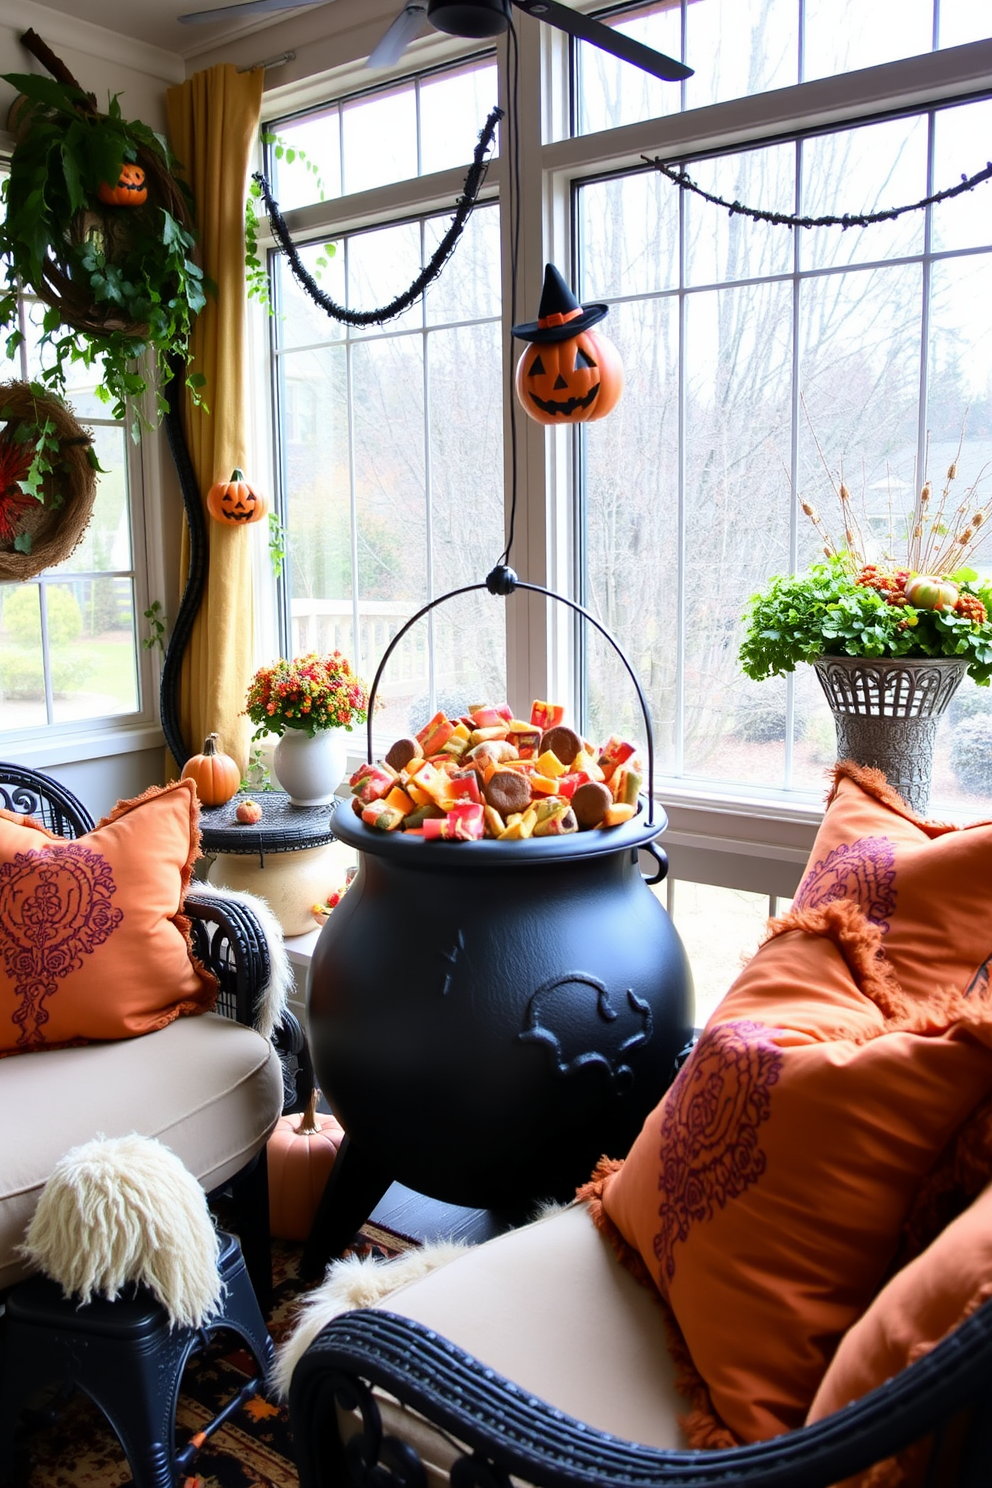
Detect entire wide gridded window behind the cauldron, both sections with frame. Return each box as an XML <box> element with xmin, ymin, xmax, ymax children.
<box><xmin>258</xmin><ymin>0</ymin><xmax>992</xmax><ymax>833</ymax></box>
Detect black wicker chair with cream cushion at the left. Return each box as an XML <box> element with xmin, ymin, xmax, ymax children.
<box><xmin>0</xmin><ymin>762</ymin><xmax>312</xmax><ymax>1308</ymax></box>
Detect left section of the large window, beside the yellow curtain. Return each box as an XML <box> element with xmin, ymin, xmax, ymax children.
<box><xmin>272</xmin><ymin>62</ymin><xmax>506</xmax><ymax>735</ymax></box>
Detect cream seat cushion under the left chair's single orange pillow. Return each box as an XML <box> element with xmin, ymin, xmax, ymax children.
<box><xmin>0</xmin><ymin>1013</ymin><xmax>283</xmax><ymax>1289</ymax></box>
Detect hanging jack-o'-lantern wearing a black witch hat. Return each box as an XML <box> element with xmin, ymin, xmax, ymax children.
<box><xmin>513</xmin><ymin>263</ymin><xmax>623</xmax><ymax>424</ymax></box>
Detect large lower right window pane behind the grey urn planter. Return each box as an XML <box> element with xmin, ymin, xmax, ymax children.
<box><xmin>574</xmin><ymin>90</ymin><xmax>992</xmax><ymax>809</ymax></box>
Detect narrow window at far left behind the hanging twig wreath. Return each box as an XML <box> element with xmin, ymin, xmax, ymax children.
<box><xmin>0</xmin><ymin>291</ymin><xmax>152</xmax><ymax>751</ymax></box>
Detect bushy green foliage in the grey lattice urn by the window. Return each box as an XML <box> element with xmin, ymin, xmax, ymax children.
<box><xmin>739</xmin><ymin>558</ymin><xmax>992</xmax><ymax>686</ymax></box>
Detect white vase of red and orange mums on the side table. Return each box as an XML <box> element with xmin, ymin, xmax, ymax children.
<box><xmin>244</xmin><ymin>650</ymin><xmax>369</xmax><ymax>806</ymax></box>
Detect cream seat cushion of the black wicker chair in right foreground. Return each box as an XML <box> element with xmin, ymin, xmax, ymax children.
<box><xmin>345</xmin><ymin>1204</ymin><xmax>690</xmax><ymax>1484</ymax></box>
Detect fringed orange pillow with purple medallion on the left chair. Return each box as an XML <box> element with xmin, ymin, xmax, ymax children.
<box><xmin>0</xmin><ymin>780</ymin><xmax>217</xmax><ymax>1054</ymax></box>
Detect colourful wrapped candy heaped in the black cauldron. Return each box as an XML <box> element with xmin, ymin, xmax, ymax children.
<box><xmin>350</xmin><ymin>699</ymin><xmax>641</xmax><ymax>842</ymax></box>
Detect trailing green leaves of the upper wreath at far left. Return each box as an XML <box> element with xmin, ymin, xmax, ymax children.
<box><xmin>0</xmin><ymin>73</ymin><xmax>207</xmax><ymax>437</ymax></box>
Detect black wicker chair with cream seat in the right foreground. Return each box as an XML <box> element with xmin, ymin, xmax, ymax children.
<box><xmin>290</xmin><ymin>1205</ymin><xmax>992</xmax><ymax>1488</ymax></box>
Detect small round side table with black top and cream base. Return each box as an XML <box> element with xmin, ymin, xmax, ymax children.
<box><xmin>199</xmin><ymin>790</ymin><xmax>355</xmax><ymax>936</ymax></box>
